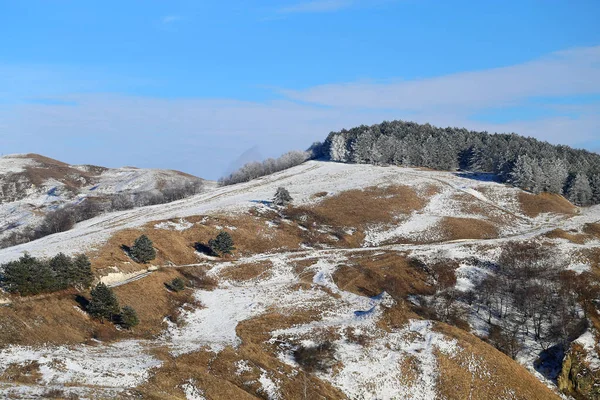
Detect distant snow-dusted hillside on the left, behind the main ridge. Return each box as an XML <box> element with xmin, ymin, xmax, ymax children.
<box><xmin>0</xmin><ymin>154</ymin><xmax>202</xmax><ymax>247</ymax></box>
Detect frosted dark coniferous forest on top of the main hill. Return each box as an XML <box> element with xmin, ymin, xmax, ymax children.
<box><xmin>312</xmin><ymin>121</ymin><xmax>600</xmax><ymax>206</ymax></box>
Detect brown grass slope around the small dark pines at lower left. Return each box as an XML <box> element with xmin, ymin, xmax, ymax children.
<box><xmin>0</xmin><ymin>269</ymin><xmax>204</xmax><ymax>348</ymax></box>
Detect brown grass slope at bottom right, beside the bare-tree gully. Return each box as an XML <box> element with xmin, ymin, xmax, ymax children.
<box><xmin>435</xmin><ymin>323</ymin><xmax>559</xmax><ymax>400</ymax></box>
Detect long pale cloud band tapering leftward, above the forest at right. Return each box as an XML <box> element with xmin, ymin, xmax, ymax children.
<box><xmin>281</xmin><ymin>46</ymin><xmax>600</xmax><ymax>111</ymax></box>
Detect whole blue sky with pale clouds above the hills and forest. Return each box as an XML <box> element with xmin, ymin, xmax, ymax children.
<box><xmin>0</xmin><ymin>0</ymin><xmax>600</xmax><ymax>178</ymax></box>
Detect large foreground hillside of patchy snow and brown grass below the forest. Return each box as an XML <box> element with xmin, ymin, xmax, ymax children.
<box><xmin>0</xmin><ymin>161</ymin><xmax>600</xmax><ymax>399</ymax></box>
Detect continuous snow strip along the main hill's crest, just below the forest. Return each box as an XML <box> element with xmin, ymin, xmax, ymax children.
<box><xmin>0</xmin><ymin>161</ymin><xmax>600</xmax><ymax>263</ymax></box>
